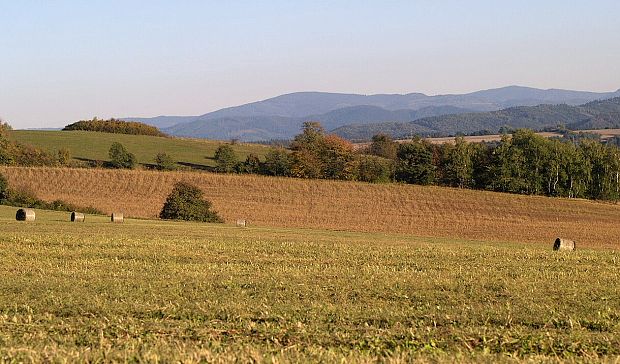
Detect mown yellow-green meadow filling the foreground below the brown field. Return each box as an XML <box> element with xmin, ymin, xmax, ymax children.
<box><xmin>0</xmin><ymin>206</ymin><xmax>620</xmax><ymax>362</ymax></box>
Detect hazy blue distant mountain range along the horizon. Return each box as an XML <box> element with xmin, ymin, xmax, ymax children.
<box><xmin>123</xmin><ymin>86</ymin><xmax>620</xmax><ymax>141</ymax></box>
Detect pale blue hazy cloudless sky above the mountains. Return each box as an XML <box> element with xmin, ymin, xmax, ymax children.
<box><xmin>0</xmin><ymin>0</ymin><xmax>620</xmax><ymax>128</ymax></box>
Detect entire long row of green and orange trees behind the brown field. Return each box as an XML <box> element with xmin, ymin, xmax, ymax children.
<box><xmin>215</xmin><ymin>122</ymin><xmax>620</xmax><ymax>201</ymax></box>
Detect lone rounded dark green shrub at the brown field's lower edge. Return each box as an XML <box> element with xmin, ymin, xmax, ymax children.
<box><xmin>159</xmin><ymin>182</ymin><xmax>224</xmax><ymax>222</ymax></box>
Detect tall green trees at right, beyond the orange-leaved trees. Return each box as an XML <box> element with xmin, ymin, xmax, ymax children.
<box><xmin>382</xmin><ymin>129</ymin><xmax>620</xmax><ymax>200</ymax></box>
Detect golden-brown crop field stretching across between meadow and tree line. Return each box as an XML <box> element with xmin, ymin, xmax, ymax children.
<box><xmin>0</xmin><ymin>167</ymin><xmax>620</xmax><ymax>248</ymax></box>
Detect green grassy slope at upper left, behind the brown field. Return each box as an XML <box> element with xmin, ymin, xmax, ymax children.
<box><xmin>11</xmin><ymin>130</ymin><xmax>268</xmax><ymax>166</ymax></box>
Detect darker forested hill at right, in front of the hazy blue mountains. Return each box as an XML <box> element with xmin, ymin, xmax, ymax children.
<box><xmin>333</xmin><ymin>97</ymin><xmax>620</xmax><ymax>140</ymax></box>
